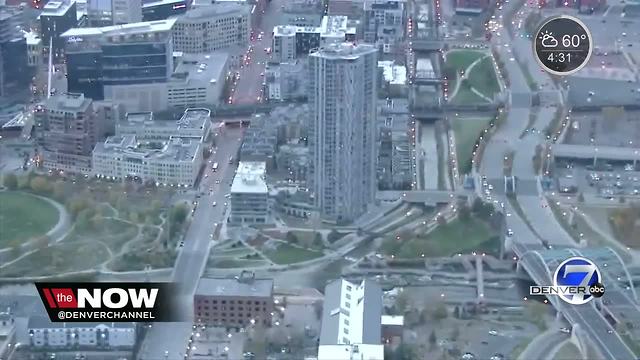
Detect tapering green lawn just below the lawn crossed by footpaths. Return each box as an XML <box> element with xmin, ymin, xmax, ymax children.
<box><xmin>451</xmin><ymin>118</ymin><xmax>491</xmax><ymax>173</ymax></box>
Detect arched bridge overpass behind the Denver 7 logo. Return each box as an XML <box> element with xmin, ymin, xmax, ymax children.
<box><xmin>513</xmin><ymin>242</ymin><xmax>640</xmax><ymax>360</ymax></box>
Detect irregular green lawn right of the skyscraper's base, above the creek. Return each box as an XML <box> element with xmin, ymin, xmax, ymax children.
<box><xmin>382</xmin><ymin>217</ymin><xmax>499</xmax><ymax>259</ymax></box>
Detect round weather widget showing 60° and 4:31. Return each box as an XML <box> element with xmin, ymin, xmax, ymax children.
<box><xmin>533</xmin><ymin>15</ymin><xmax>593</xmax><ymax>75</ymax></box>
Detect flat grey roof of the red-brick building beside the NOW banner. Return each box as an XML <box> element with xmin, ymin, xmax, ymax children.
<box><xmin>196</xmin><ymin>273</ymin><xmax>273</xmax><ymax>297</ymax></box>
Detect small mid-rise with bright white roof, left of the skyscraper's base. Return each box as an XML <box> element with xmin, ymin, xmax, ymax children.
<box><xmin>229</xmin><ymin>161</ymin><xmax>269</xmax><ymax>225</ymax></box>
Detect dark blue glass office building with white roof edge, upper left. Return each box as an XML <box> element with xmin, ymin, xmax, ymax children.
<box><xmin>62</xmin><ymin>19</ymin><xmax>175</xmax><ymax>102</ymax></box>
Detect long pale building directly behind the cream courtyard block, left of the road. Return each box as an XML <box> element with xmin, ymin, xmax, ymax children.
<box><xmin>116</xmin><ymin>109</ymin><xmax>211</xmax><ymax>140</ymax></box>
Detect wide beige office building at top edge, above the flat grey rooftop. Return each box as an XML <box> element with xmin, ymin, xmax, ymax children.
<box><xmin>173</xmin><ymin>3</ymin><xmax>251</xmax><ymax>53</ymax></box>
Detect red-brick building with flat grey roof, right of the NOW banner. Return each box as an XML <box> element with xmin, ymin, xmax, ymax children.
<box><xmin>193</xmin><ymin>271</ymin><xmax>273</xmax><ymax>328</ymax></box>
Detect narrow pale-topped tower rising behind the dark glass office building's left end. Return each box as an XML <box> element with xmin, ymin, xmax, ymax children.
<box><xmin>39</xmin><ymin>0</ymin><xmax>78</xmax><ymax>61</ymax></box>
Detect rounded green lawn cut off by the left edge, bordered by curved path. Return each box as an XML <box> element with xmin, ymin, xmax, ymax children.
<box><xmin>0</xmin><ymin>191</ymin><xmax>60</xmax><ymax>248</ymax></box>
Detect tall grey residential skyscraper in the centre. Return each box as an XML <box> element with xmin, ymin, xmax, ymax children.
<box><xmin>307</xmin><ymin>43</ymin><xmax>377</xmax><ymax>221</ymax></box>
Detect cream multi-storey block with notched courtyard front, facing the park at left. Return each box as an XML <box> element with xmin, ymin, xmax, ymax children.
<box><xmin>93</xmin><ymin>135</ymin><xmax>203</xmax><ymax>186</ymax></box>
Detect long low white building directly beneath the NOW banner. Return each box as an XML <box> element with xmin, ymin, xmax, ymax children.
<box><xmin>27</xmin><ymin>316</ymin><xmax>136</xmax><ymax>350</ymax></box>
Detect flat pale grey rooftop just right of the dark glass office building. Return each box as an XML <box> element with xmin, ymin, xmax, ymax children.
<box><xmin>171</xmin><ymin>52</ymin><xmax>229</xmax><ymax>84</ymax></box>
